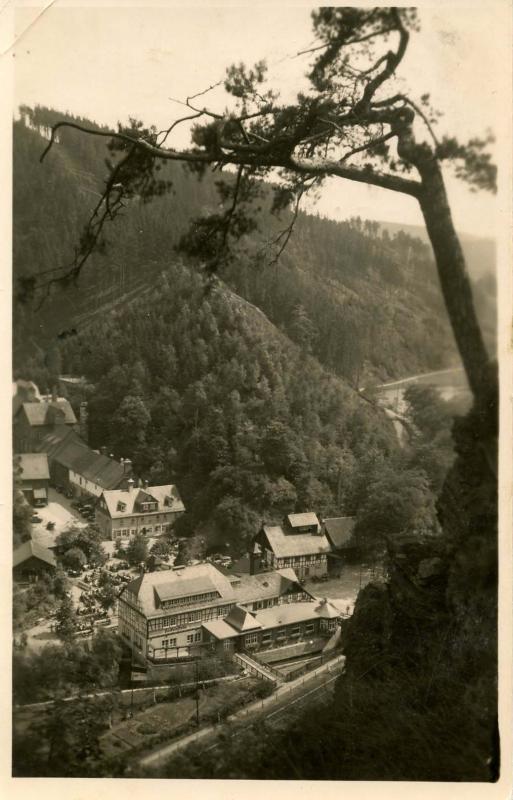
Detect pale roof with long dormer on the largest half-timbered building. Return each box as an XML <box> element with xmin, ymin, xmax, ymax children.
<box><xmin>121</xmin><ymin>563</ymin><xmax>234</xmax><ymax>617</ymax></box>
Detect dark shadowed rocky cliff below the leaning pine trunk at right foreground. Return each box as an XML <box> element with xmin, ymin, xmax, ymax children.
<box><xmin>336</xmin><ymin>378</ymin><xmax>499</xmax><ymax>781</ymax></box>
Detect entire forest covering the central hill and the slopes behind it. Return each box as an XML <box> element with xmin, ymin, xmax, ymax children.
<box><xmin>14</xmin><ymin>109</ymin><xmax>468</xmax><ymax>552</ymax></box>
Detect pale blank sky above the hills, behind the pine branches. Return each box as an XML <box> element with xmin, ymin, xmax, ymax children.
<box><xmin>9</xmin><ymin>0</ymin><xmax>503</xmax><ymax>236</ymax></box>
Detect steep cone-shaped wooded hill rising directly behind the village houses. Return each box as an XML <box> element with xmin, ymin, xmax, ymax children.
<box><xmin>59</xmin><ymin>263</ymin><xmax>397</xmax><ymax>552</ymax></box>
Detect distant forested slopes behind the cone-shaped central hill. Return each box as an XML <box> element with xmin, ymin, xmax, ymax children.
<box><xmin>14</xmin><ymin>108</ymin><xmax>493</xmax><ymax>386</ymax></box>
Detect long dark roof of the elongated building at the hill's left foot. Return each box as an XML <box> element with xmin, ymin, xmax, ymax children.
<box><xmin>38</xmin><ymin>429</ymin><xmax>128</xmax><ymax>489</ymax></box>
